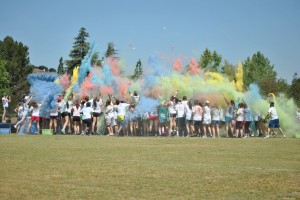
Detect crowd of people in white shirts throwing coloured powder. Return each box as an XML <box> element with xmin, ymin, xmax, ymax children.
<box><xmin>2</xmin><ymin>91</ymin><xmax>292</xmax><ymax>138</ymax></box>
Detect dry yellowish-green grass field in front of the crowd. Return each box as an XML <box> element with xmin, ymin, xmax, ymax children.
<box><xmin>0</xmin><ymin>135</ymin><xmax>300</xmax><ymax>200</ymax></box>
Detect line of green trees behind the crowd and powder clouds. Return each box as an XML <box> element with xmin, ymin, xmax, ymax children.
<box><xmin>0</xmin><ymin>27</ymin><xmax>300</xmax><ymax>115</ymax></box>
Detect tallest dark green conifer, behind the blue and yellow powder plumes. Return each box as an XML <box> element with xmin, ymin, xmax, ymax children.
<box><xmin>66</xmin><ymin>27</ymin><xmax>90</xmax><ymax>74</ymax></box>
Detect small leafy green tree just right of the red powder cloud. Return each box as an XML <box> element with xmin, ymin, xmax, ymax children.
<box><xmin>200</xmin><ymin>48</ymin><xmax>222</xmax><ymax>72</ymax></box>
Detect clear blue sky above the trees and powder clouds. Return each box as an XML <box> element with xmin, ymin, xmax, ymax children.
<box><xmin>0</xmin><ymin>0</ymin><xmax>300</xmax><ymax>82</ymax></box>
